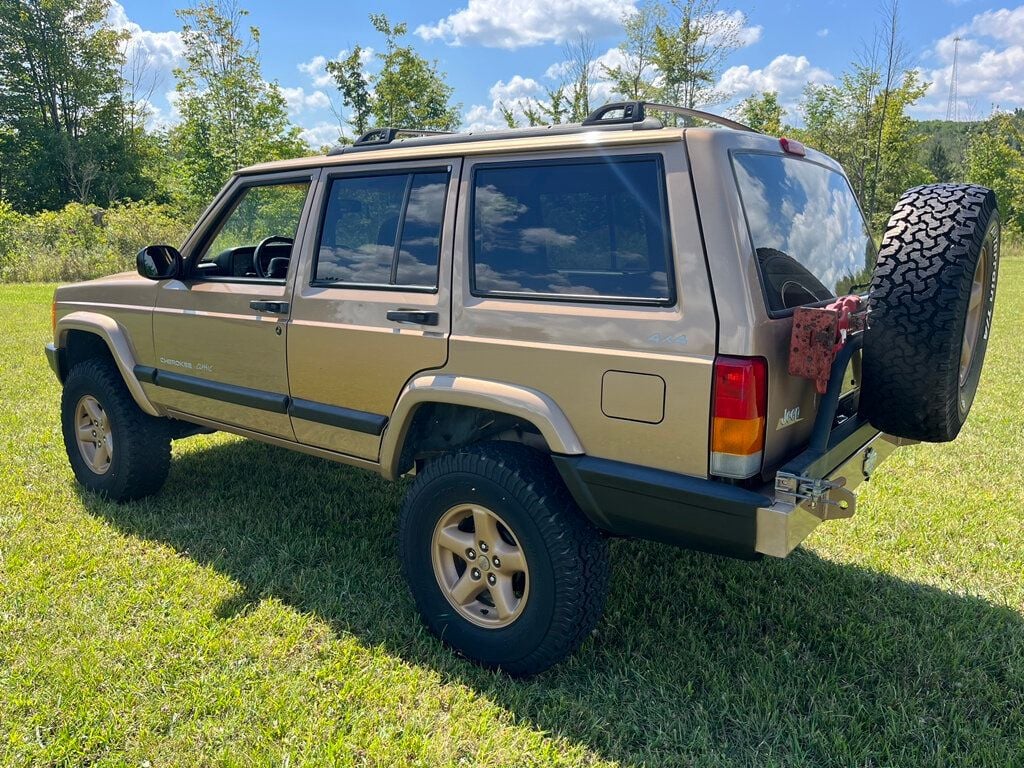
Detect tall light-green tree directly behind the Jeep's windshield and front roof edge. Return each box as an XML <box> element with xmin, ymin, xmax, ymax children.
<box><xmin>170</xmin><ymin>0</ymin><xmax>309</xmax><ymax>207</ymax></box>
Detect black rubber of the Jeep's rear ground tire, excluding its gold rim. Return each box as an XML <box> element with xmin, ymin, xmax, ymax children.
<box><xmin>398</xmin><ymin>442</ymin><xmax>609</xmax><ymax>676</ymax></box>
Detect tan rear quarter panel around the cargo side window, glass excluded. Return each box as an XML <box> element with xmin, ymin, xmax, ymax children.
<box><xmin>445</xmin><ymin>140</ymin><xmax>716</xmax><ymax>477</ymax></box>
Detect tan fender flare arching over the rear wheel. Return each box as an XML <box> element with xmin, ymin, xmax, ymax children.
<box><xmin>381</xmin><ymin>374</ymin><xmax>584</xmax><ymax>479</ymax></box>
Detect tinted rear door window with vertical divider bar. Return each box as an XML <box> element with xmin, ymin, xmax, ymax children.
<box><xmin>313</xmin><ymin>171</ymin><xmax>449</xmax><ymax>290</ymax></box>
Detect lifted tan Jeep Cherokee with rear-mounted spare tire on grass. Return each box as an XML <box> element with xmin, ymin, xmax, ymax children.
<box><xmin>47</xmin><ymin>102</ymin><xmax>999</xmax><ymax>675</ymax></box>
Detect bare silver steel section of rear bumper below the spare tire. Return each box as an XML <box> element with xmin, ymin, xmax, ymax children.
<box><xmin>755</xmin><ymin>427</ymin><xmax>909</xmax><ymax>557</ymax></box>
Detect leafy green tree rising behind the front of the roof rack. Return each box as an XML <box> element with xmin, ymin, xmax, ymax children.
<box><xmin>327</xmin><ymin>13</ymin><xmax>461</xmax><ymax>133</ymax></box>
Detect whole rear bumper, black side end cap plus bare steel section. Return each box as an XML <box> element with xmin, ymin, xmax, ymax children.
<box><xmin>554</xmin><ymin>424</ymin><xmax>899</xmax><ymax>559</ymax></box>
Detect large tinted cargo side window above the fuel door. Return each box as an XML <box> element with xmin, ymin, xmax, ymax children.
<box><xmin>472</xmin><ymin>157</ymin><xmax>673</xmax><ymax>303</ymax></box>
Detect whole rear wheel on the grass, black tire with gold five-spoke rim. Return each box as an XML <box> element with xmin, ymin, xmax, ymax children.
<box><xmin>398</xmin><ymin>442</ymin><xmax>608</xmax><ymax>675</ymax></box>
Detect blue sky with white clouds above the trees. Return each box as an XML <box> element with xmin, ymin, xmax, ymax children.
<box><xmin>111</xmin><ymin>0</ymin><xmax>1024</xmax><ymax>145</ymax></box>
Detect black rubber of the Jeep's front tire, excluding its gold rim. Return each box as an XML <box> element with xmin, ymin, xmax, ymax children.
<box><xmin>60</xmin><ymin>358</ymin><xmax>171</xmax><ymax>502</ymax></box>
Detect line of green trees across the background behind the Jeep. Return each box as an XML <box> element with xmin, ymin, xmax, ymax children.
<box><xmin>0</xmin><ymin>0</ymin><xmax>1024</xmax><ymax>276</ymax></box>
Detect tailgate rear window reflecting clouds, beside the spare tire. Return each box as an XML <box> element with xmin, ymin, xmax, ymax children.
<box><xmin>732</xmin><ymin>154</ymin><xmax>876</xmax><ymax>311</ymax></box>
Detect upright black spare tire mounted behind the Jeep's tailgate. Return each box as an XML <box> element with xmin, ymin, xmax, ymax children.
<box><xmin>860</xmin><ymin>184</ymin><xmax>999</xmax><ymax>442</ymax></box>
